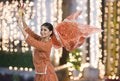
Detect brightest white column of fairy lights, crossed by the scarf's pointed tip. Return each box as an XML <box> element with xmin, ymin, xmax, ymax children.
<box><xmin>90</xmin><ymin>0</ymin><xmax>101</xmax><ymax>68</ymax></box>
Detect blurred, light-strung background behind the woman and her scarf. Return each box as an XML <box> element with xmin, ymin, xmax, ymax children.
<box><xmin>0</xmin><ymin>0</ymin><xmax>120</xmax><ymax>81</ymax></box>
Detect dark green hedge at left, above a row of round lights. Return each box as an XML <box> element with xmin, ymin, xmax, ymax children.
<box><xmin>0</xmin><ymin>51</ymin><xmax>34</xmax><ymax>68</ymax></box>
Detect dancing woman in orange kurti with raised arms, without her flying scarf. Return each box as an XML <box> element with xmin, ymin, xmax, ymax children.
<box><xmin>18</xmin><ymin>7</ymin><xmax>58</xmax><ymax>81</ymax></box>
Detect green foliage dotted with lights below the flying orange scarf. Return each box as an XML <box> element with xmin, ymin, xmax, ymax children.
<box><xmin>68</xmin><ymin>49</ymin><xmax>81</xmax><ymax>70</ymax></box>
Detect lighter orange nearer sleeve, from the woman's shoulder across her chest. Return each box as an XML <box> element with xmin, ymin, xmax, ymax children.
<box><xmin>26</xmin><ymin>35</ymin><xmax>52</xmax><ymax>51</ymax></box>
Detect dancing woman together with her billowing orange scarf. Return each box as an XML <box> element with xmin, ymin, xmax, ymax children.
<box><xmin>19</xmin><ymin>3</ymin><xmax>101</xmax><ymax>81</ymax></box>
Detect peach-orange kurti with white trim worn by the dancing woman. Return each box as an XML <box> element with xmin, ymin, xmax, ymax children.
<box><xmin>26</xmin><ymin>28</ymin><xmax>58</xmax><ymax>81</ymax></box>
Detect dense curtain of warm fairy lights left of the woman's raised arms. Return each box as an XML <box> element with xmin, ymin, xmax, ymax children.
<box><xmin>0</xmin><ymin>0</ymin><xmax>34</xmax><ymax>52</ymax></box>
